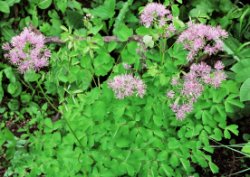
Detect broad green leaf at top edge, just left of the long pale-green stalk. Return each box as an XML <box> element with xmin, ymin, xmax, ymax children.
<box><xmin>91</xmin><ymin>0</ymin><xmax>116</xmax><ymax>20</ymax></box>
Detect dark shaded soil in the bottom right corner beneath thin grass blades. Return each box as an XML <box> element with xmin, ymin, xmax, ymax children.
<box><xmin>196</xmin><ymin>117</ymin><xmax>250</xmax><ymax>177</ymax></box>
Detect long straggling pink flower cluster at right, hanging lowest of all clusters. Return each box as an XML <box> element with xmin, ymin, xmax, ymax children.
<box><xmin>167</xmin><ymin>61</ymin><xmax>226</xmax><ymax>120</ymax></box>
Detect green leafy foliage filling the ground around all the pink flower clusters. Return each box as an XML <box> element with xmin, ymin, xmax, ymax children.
<box><xmin>0</xmin><ymin>0</ymin><xmax>250</xmax><ymax>177</ymax></box>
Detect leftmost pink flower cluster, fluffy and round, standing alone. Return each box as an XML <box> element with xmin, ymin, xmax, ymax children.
<box><xmin>2</xmin><ymin>28</ymin><xmax>51</xmax><ymax>73</ymax></box>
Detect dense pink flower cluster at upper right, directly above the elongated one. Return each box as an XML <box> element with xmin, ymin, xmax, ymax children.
<box><xmin>177</xmin><ymin>22</ymin><xmax>228</xmax><ymax>61</ymax></box>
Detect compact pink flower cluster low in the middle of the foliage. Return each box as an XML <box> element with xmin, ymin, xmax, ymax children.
<box><xmin>108</xmin><ymin>74</ymin><xmax>146</xmax><ymax>99</ymax></box>
